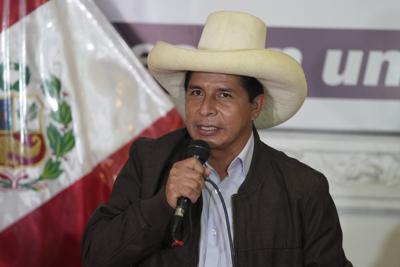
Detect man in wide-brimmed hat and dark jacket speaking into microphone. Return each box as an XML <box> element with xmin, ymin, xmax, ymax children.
<box><xmin>82</xmin><ymin>12</ymin><xmax>352</xmax><ymax>267</ymax></box>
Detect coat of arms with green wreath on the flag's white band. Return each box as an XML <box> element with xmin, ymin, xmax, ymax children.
<box><xmin>0</xmin><ymin>62</ymin><xmax>75</xmax><ymax>190</ymax></box>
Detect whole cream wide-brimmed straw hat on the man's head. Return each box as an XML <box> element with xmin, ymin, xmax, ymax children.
<box><xmin>148</xmin><ymin>11</ymin><xmax>307</xmax><ymax>128</ymax></box>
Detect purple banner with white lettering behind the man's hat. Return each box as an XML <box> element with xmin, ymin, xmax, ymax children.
<box><xmin>114</xmin><ymin>23</ymin><xmax>400</xmax><ymax>99</ymax></box>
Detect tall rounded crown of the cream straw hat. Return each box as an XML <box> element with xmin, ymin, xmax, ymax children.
<box><xmin>198</xmin><ymin>11</ymin><xmax>267</xmax><ymax>50</ymax></box>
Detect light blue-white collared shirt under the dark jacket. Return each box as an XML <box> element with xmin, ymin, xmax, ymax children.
<box><xmin>198</xmin><ymin>133</ymin><xmax>254</xmax><ymax>267</ymax></box>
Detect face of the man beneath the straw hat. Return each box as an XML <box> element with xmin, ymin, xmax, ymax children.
<box><xmin>185</xmin><ymin>72</ymin><xmax>264</xmax><ymax>156</ymax></box>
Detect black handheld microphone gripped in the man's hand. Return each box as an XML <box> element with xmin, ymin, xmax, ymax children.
<box><xmin>171</xmin><ymin>140</ymin><xmax>210</xmax><ymax>246</ymax></box>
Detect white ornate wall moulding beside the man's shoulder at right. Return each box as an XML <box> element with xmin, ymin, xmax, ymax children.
<box><xmin>260</xmin><ymin>130</ymin><xmax>400</xmax><ymax>214</ymax></box>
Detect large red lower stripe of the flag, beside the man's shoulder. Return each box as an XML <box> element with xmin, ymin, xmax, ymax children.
<box><xmin>0</xmin><ymin>109</ymin><xmax>182</xmax><ymax>267</ymax></box>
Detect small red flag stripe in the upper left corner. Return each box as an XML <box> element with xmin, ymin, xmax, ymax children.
<box><xmin>0</xmin><ymin>0</ymin><xmax>48</xmax><ymax>32</ymax></box>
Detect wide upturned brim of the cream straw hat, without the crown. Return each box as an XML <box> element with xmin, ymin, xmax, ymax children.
<box><xmin>148</xmin><ymin>42</ymin><xmax>307</xmax><ymax>128</ymax></box>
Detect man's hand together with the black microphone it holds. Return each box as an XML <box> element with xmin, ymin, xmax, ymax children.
<box><xmin>166</xmin><ymin>140</ymin><xmax>210</xmax><ymax>245</ymax></box>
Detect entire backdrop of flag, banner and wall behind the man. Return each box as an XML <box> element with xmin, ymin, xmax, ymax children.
<box><xmin>0</xmin><ymin>0</ymin><xmax>400</xmax><ymax>267</ymax></box>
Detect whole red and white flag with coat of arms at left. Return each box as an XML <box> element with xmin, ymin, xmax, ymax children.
<box><xmin>0</xmin><ymin>0</ymin><xmax>182</xmax><ymax>267</ymax></box>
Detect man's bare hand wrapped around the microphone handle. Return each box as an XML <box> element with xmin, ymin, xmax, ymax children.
<box><xmin>165</xmin><ymin>158</ymin><xmax>211</xmax><ymax>208</ymax></box>
